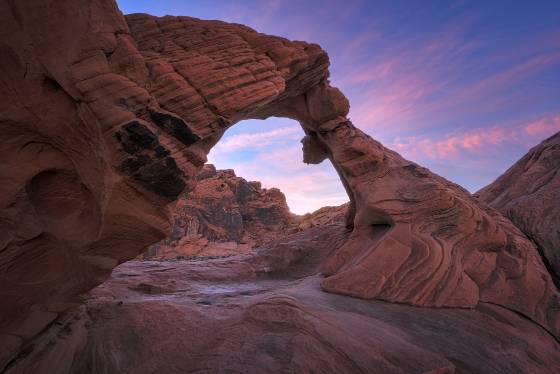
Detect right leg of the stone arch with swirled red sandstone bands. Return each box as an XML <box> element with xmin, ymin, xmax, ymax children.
<box><xmin>265</xmin><ymin>89</ymin><xmax>560</xmax><ymax>335</ymax></box>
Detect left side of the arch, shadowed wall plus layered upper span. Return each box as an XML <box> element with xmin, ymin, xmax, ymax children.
<box><xmin>0</xmin><ymin>0</ymin><xmax>328</xmax><ymax>356</ymax></box>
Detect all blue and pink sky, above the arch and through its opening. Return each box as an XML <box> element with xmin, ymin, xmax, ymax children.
<box><xmin>117</xmin><ymin>0</ymin><xmax>560</xmax><ymax>214</ymax></box>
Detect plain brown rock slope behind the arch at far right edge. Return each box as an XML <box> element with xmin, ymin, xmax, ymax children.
<box><xmin>477</xmin><ymin>133</ymin><xmax>560</xmax><ymax>285</ymax></box>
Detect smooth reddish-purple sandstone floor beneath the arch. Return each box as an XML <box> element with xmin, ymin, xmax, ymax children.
<box><xmin>6</xmin><ymin>223</ymin><xmax>560</xmax><ymax>374</ymax></box>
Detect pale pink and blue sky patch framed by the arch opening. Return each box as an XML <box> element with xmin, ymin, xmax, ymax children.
<box><xmin>208</xmin><ymin>117</ymin><xmax>348</xmax><ymax>215</ymax></box>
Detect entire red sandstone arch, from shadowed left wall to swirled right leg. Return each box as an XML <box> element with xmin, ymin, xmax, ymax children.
<box><xmin>0</xmin><ymin>0</ymin><xmax>560</xmax><ymax>366</ymax></box>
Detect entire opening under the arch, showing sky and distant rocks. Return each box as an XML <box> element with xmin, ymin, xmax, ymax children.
<box><xmin>141</xmin><ymin>116</ymin><xmax>349</xmax><ymax>259</ymax></box>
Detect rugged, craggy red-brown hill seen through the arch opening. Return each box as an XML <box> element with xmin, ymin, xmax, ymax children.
<box><xmin>143</xmin><ymin>164</ymin><xmax>297</xmax><ymax>259</ymax></box>
